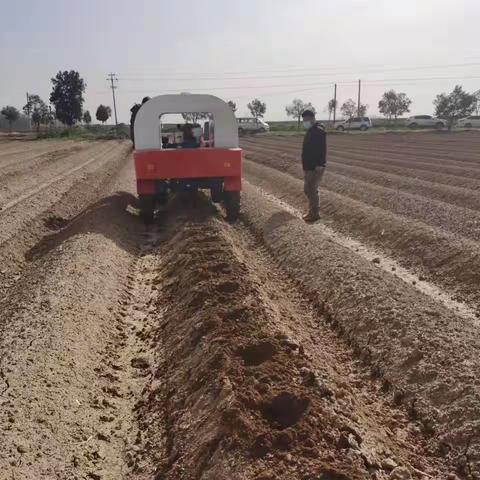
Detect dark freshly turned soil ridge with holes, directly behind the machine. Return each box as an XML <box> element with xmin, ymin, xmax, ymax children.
<box><xmin>129</xmin><ymin>198</ymin><xmax>448</xmax><ymax>480</ymax></box>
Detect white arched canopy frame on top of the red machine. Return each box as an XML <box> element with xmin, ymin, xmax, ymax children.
<box><xmin>134</xmin><ymin>94</ymin><xmax>238</xmax><ymax>150</ymax></box>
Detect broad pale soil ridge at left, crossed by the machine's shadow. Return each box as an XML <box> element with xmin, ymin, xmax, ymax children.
<box><xmin>0</xmin><ymin>152</ymin><xmax>158</xmax><ymax>480</ymax></box>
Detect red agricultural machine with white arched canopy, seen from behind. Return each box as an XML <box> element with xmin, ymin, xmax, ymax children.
<box><xmin>133</xmin><ymin>94</ymin><xmax>242</xmax><ymax>221</ymax></box>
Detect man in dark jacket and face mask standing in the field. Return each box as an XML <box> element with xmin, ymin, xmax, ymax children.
<box><xmin>302</xmin><ymin>110</ymin><xmax>327</xmax><ymax>223</ymax></box>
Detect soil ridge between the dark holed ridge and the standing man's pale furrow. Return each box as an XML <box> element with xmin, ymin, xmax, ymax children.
<box><xmin>242</xmin><ymin>184</ymin><xmax>480</xmax><ymax>479</ymax></box>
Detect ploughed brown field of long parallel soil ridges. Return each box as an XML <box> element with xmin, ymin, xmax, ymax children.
<box><xmin>0</xmin><ymin>133</ymin><xmax>480</xmax><ymax>480</ymax></box>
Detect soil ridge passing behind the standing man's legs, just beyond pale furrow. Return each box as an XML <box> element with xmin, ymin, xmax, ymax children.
<box><xmin>244</xmin><ymin>161</ymin><xmax>480</xmax><ymax>317</ymax></box>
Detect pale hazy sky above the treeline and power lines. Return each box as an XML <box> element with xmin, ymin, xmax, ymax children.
<box><xmin>0</xmin><ymin>0</ymin><xmax>480</xmax><ymax>123</ymax></box>
